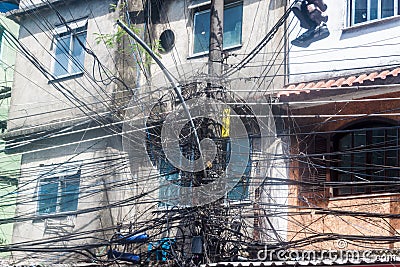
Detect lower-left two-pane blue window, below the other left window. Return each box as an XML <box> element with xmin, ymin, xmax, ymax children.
<box><xmin>38</xmin><ymin>169</ymin><xmax>81</xmax><ymax>215</ymax></box>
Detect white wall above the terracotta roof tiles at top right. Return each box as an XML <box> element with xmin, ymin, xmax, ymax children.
<box><xmin>289</xmin><ymin>0</ymin><xmax>400</xmax><ymax>82</ymax></box>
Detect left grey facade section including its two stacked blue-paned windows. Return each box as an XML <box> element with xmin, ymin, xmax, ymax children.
<box><xmin>5</xmin><ymin>1</ymin><xmax>136</xmax><ymax>264</ymax></box>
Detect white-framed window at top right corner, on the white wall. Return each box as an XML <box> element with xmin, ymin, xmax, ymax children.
<box><xmin>350</xmin><ymin>0</ymin><xmax>399</xmax><ymax>25</ymax></box>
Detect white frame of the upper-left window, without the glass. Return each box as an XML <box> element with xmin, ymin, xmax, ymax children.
<box><xmin>52</xmin><ymin>19</ymin><xmax>88</xmax><ymax>79</ymax></box>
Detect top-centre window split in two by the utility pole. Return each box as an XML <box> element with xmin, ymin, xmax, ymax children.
<box><xmin>193</xmin><ymin>2</ymin><xmax>243</xmax><ymax>54</ymax></box>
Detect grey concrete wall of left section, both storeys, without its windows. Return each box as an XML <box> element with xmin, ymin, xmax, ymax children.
<box><xmin>8</xmin><ymin>0</ymin><xmax>133</xmax><ymax>264</ymax></box>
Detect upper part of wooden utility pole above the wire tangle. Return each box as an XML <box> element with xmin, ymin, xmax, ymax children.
<box><xmin>208</xmin><ymin>0</ymin><xmax>224</xmax><ymax>77</ymax></box>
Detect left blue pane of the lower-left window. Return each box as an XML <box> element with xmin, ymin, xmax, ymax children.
<box><xmin>38</xmin><ymin>178</ymin><xmax>58</xmax><ymax>214</ymax></box>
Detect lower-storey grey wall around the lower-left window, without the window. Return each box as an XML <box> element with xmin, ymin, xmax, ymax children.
<box><xmin>12</xmin><ymin>131</ymin><xmax>133</xmax><ymax>264</ymax></box>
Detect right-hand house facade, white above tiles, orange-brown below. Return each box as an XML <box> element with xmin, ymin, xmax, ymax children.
<box><xmin>279</xmin><ymin>0</ymin><xmax>399</xmax><ymax>253</ymax></box>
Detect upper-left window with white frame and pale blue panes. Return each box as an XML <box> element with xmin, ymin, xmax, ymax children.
<box><xmin>53</xmin><ymin>21</ymin><xmax>87</xmax><ymax>78</ymax></box>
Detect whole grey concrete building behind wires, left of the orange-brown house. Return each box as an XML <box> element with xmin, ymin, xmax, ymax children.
<box><xmin>1</xmin><ymin>0</ymin><xmax>288</xmax><ymax>264</ymax></box>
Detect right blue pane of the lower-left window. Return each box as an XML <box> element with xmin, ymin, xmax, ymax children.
<box><xmin>60</xmin><ymin>173</ymin><xmax>80</xmax><ymax>212</ymax></box>
